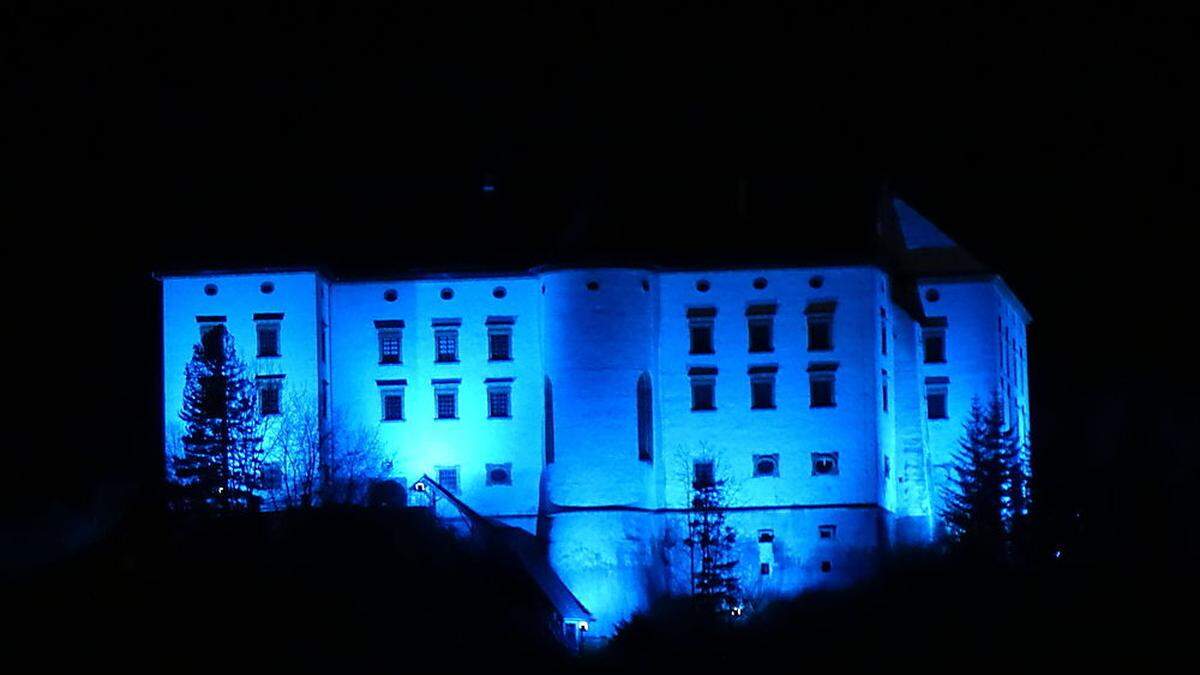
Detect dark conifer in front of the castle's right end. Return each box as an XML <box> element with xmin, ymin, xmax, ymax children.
<box><xmin>942</xmin><ymin>396</ymin><xmax>1012</xmax><ymax>562</ymax></box>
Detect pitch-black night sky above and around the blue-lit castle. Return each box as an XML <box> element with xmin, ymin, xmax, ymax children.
<box><xmin>11</xmin><ymin>2</ymin><xmax>1200</xmax><ymax>555</ymax></box>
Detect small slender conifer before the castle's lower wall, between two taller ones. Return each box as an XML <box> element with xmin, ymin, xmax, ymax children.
<box><xmin>684</xmin><ymin>466</ymin><xmax>742</xmax><ymax>614</ymax></box>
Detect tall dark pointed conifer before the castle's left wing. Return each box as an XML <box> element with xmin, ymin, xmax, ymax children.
<box><xmin>173</xmin><ymin>325</ymin><xmax>263</xmax><ymax>510</ymax></box>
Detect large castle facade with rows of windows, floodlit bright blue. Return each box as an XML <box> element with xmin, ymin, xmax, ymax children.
<box><xmin>162</xmin><ymin>201</ymin><xmax>1030</xmax><ymax>635</ymax></box>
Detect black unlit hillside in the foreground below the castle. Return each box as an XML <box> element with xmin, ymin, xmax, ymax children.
<box><xmin>2</xmin><ymin>510</ymin><xmax>1196</xmax><ymax>673</ymax></box>
